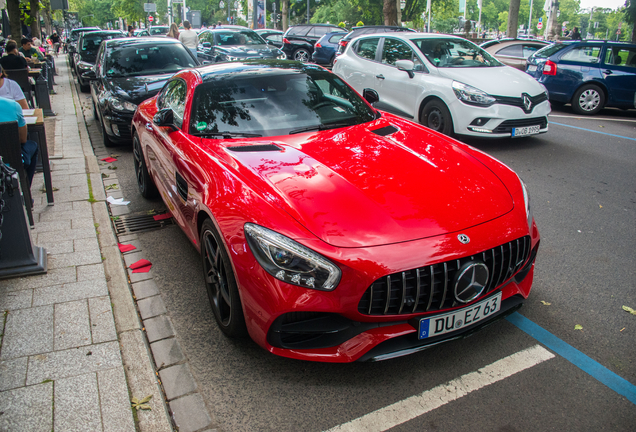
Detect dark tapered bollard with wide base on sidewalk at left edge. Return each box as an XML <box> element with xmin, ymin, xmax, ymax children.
<box><xmin>0</xmin><ymin>167</ymin><xmax>47</xmax><ymax>279</ymax></box>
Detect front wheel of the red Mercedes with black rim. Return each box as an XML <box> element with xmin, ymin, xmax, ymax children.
<box><xmin>201</xmin><ymin>219</ymin><xmax>247</xmax><ymax>337</ymax></box>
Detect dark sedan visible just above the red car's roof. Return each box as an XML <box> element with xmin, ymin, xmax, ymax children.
<box><xmin>197</xmin><ymin>28</ymin><xmax>285</xmax><ymax>63</ymax></box>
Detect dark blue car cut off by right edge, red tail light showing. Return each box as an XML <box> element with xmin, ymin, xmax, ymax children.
<box><xmin>526</xmin><ymin>40</ymin><xmax>636</xmax><ymax>114</ymax></box>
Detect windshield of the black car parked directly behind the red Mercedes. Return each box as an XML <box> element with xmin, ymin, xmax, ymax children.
<box><xmin>106</xmin><ymin>43</ymin><xmax>197</xmax><ymax>78</ymax></box>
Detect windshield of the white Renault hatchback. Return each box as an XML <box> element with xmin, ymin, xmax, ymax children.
<box><xmin>411</xmin><ymin>39</ymin><xmax>503</xmax><ymax>68</ymax></box>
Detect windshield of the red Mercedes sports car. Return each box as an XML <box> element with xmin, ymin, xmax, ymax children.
<box><xmin>190</xmin><ymin>70</ymin><xmax>375</xmax><ymax>136</ymax></box>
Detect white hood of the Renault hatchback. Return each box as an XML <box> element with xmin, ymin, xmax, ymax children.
<box><xmin>438</xmin><ymin>66</ymin><xmax>545</xmax><ymax>97</ymax></box>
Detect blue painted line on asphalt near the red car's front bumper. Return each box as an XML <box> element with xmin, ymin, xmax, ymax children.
<box><xmin>506</xmin><ymin>312</ymin><xmax>636</xmax><ymax>404</ymax></box>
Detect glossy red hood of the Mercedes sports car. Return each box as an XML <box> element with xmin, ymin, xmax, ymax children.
<box><xmin>221</xmin><ymin>120</ymin><xmax>513</xmax><ymax>247</ymax></box>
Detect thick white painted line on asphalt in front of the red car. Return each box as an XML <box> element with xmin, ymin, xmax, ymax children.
<box><xmin>328</xmin><ymin>345</ymin><xmax>555</xmax><ymax>432</ymax></box>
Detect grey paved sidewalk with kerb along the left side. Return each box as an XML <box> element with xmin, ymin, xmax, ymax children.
<box><xmin>0</xmin><ymin>55</ymin><xmax>173</xmax><ymax>432</ymax></box>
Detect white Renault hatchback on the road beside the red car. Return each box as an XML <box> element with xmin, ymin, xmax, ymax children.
<box><xmin>333</xmin><ymin>33</ymin><xmax>550</xmax><ymax>137</ymax></box>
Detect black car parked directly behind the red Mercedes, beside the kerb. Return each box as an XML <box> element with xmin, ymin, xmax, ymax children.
<box><xmin>82</xmin><ymin>37</ymin><xmax>199</xmax><ymax>147</ymax></box>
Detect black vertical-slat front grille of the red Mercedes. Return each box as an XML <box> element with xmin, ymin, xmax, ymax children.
<box><xmin>358</xmin><ymin>236</ymin><xmax>531</xmax><ymax>315</ymax></box>
